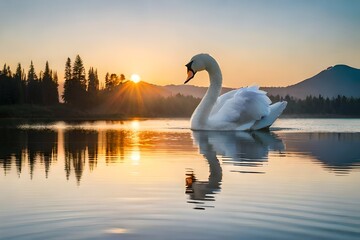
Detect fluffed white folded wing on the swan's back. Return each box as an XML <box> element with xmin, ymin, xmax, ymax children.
<box><xmin>209</xmin><ymin>86</ymin><xmax>271</xmax><ymax>128</ymax></box>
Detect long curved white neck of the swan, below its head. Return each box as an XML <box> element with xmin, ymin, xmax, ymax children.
<box><xmin>191</xmin><ymin>61</ymin><xmax>222</xmax><ymax>129</ymax></box>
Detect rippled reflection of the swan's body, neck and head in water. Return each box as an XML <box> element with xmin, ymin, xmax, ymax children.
<box><xmin>186</xmin><ymin>131</ymin><xmax>285</xmax><ymax>210</ymax></box>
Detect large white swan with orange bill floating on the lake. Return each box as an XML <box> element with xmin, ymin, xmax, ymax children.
<box><xmin>184</xmin><ymin>53</ymin><xmax>287</xmax><ymax>131</ymax></box>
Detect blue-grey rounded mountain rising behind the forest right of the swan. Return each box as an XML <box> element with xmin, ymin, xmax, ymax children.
<box><xmin>262</xmin><ymin>65</ymin><xmax>360</xmax><ymax>99</ymax></box>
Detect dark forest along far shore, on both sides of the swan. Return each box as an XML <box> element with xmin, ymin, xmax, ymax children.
<box><xmin>0</xmin><ymin>55</ymin><xmax>360</xmax><ymax>119</ymax></box>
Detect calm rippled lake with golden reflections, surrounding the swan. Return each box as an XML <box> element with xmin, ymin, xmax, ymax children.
<box><xmin>0</xmin><ymin>119</ymin><xmax>360</xmax><ymax>239</ymax></box>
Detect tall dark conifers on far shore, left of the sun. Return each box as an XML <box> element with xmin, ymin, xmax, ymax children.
<box><xmin>0</xmin><ymin>55</ymin><xmax>125</xmax><ymax>109</ymax></box>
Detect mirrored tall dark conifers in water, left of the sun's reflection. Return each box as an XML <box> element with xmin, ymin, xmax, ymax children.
<box><xmin>0</xmin><ymin>128</ymin><xmax>133</xmax><ymax>183</ymax></box>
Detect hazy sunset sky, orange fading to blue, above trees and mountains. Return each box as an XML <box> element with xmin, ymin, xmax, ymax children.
<box><xmin>0</xmin><ymin>0</ymin><xmax>360</xmax><ymax>87</ymax></box>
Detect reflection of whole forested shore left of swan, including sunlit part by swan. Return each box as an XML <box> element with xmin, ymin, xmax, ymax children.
<box><xmin>0</xmin><ymin>128</ymin><xmax>191</xmax><ymax>183</ymax></box>
